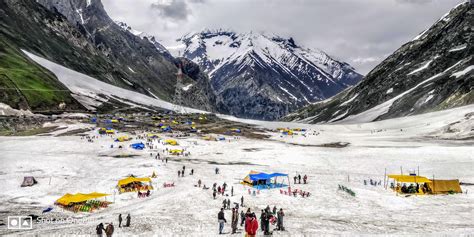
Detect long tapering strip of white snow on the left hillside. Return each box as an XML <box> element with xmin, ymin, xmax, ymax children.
<box><xmin>23</xmin><ymin>50</ymin><xmax>206</xmax><ymax>113</ymax></box>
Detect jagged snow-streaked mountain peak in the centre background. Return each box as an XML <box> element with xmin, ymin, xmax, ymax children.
<box><xmin>178</xmin><ymin>30</ymin><xmax>361</xmax><ymax>120</ymax></box>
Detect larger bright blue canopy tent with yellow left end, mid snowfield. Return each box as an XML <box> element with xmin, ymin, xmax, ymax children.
<box><xmin>241</xmin><ymin>170</ymin><xmax>290</xmax><ymax>189</ymax></box>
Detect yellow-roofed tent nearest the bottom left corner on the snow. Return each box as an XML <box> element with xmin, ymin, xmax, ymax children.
<box><xmin>55</xmin><ymin>192</ymin><xmax>110</xmax><ymax>212</ymax></box>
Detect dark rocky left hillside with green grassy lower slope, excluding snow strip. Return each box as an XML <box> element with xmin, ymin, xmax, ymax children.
<box><xmin>0</xmin><ymin>0</ymin><xmax>215</xmax><ymax>111</ymax></box>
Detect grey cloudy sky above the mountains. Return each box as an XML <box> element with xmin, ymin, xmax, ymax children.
<box><xmin>102</xmin><ymin>0</ymin><xmax>464</xmax><ymax>74</ymax></box>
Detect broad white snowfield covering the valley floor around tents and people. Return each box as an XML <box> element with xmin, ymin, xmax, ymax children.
<box><xmin>0</xmin><ymin>103</ymin><xmax>474</xmax><ymax>236</ymax></box>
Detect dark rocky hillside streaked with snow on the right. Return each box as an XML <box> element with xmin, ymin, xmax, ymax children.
<box><xmin>284</xmin><ymin>3</ymin><xmax>474</xmax><ymax>123</ymax></box>
